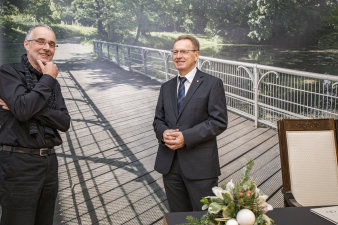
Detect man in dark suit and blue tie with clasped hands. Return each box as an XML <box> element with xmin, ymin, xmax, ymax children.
<box><xmin>153</xmin><ymin>35</ymin><xmax>228</xmax><ymax>212</ymax></box>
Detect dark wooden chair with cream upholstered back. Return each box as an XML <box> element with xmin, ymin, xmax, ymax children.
<box><xmin>278</xmin><ymin>119</ymin><xmax>338</xmax><ymax>206</ymax></box>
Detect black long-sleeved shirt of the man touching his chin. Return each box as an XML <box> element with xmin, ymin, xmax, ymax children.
<box><xmin>0</xmin><ymin>59</ymin><xmax>70</xmax><ymax>148</ymax></box>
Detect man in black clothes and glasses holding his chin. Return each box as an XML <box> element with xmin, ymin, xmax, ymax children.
<box><xmin>0</xmin><ymin>25</ymin><xmax>70</xmax><ymax>225</ymax></box>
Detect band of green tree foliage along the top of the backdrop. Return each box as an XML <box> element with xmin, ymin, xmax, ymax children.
<box><xmin>0</xmin><ymin>0</ymin><xmax>338</xmax><ymax>46</ymax></box>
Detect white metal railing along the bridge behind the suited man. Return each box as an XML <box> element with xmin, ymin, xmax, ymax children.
<box><xmin>93</xmin><ymin>41</ymin><xmax>338</xmax><ymax>128</ymax></box>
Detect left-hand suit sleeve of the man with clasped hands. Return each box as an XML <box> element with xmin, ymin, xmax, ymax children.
<box><xmin>153</xmin><ymin>85</ymin><xmax>169</xmax><ymax>142</ymax></box>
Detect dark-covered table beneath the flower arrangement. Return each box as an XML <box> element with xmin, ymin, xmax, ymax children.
<box><xmin>163</xmin><ymin>207</ymin><xmax>333</xmax><ymax>225</ymax></box>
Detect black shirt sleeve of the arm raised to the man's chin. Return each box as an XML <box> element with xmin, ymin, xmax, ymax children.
<box><xmin>0</xmin><ymin>67</ymin><xmax>56</xmax><ymax>121</ymax></box>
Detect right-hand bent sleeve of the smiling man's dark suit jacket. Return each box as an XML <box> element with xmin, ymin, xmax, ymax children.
<box><xmin>182</xmin><ymin>79</ymin><xmax>228</xmax><ymax>149</ymax></box>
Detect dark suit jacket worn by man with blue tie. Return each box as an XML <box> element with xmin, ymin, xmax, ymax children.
<box><xmin>153</xmin><ymin>70</ymin><xmax>228</xmax><ymax>179</ymax></box>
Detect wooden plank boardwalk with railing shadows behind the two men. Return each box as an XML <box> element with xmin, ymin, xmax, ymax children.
<box><xmin>50</xmin><ymin>43</ymin><xmax>283</xmax><ymax>225</ymax></box>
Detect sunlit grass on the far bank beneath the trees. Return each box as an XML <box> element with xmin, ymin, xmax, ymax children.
<box><xmin>0</xmin><ymin>15</ymin><xmax>236</xmax><ymax>55</ymax></box>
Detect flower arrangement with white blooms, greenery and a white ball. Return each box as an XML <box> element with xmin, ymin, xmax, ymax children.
<box><xmin>186</xmin><ymin>161</ymin><xmax>274</xmax><ymax>225</ymax></box>
